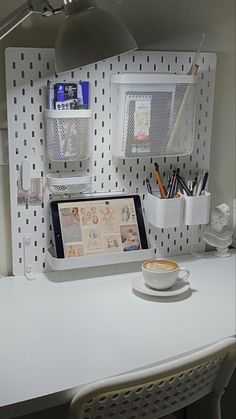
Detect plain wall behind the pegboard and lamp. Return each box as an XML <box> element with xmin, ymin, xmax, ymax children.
<box><xmin>0</xmin><ymin>0</ymin><xmax>235</xmax><ymax>274</ymax></box>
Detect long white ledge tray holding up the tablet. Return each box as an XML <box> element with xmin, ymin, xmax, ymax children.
<box><xmin>46</xmin><ymin>248</ymin><xmax>154</xmax><ymax>271</ymax></box>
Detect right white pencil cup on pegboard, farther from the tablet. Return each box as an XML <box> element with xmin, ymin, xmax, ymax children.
<box><xmin>183</xmin><ymin>192</ymin><xmax>211</xmax><ymax>225</ymax></box>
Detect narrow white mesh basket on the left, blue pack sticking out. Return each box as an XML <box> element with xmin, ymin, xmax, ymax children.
<box><xmin>45</xmin><ymin>109</ymin><xmax>92</xmax><ymax>161</ymax></box>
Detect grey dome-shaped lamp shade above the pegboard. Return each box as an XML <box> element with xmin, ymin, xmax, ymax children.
<box><xmin>55</xmin><ymin>7</ymin><xmax>138</xmax><ymax>73</ymax></box>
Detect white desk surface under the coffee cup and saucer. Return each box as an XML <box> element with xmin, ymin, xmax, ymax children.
<box><xmin>0</xmin><ymin>253</ymin><xmax>235</xmax><ymax>419</ymax></box>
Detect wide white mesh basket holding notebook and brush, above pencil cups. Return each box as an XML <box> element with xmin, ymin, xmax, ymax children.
<box><xmin>111</xmin><ymin>73</ymin><xmax>197</xmax><ymax>158</ymax></box>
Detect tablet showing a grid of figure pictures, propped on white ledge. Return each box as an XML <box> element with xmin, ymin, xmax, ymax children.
<box><xmin>52</xmin><ymin>196</ymin><xmax>147</xmax><ymax>258</ymax></box>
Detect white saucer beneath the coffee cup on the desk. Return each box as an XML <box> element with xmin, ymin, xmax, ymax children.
<box><xmin>131</xmin><ymin>274</ymin><xmax>190</xmax><ymax>297</ymax></box>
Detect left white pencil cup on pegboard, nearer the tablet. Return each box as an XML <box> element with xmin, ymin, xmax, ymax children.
<box><xmin>144</xmin><ymin>193</ymin><xmax>183</xmax><ymax>228</ymax></box>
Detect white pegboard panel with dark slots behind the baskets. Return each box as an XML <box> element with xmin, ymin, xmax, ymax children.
<box><xmin>6</xmin><ymin>48</ymin><xmax>216</xmax><ymax>275</ymax></box>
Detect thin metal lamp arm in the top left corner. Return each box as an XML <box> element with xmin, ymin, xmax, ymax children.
<box><xmin>0</xmin><ymin>0</ymin><xmax>64</xmax><ymax>40</ymax></box>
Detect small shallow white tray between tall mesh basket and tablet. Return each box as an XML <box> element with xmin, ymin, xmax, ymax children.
<box><xmin>47</xmin><ymin>172</ymin><xmax>92</xmax><ymax>195</ymax></box>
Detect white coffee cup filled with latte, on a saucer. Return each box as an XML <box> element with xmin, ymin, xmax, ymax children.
<box><xmin>142</xmin><ymin>259</ymin><xmax>190</xmax><ymax>290</ymax></box>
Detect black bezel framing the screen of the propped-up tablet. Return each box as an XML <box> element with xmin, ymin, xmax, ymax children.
<box><xmin>50</xmin><ymin>195</ymin><xmax>148</xmax><ymax>259</ymax></box>
